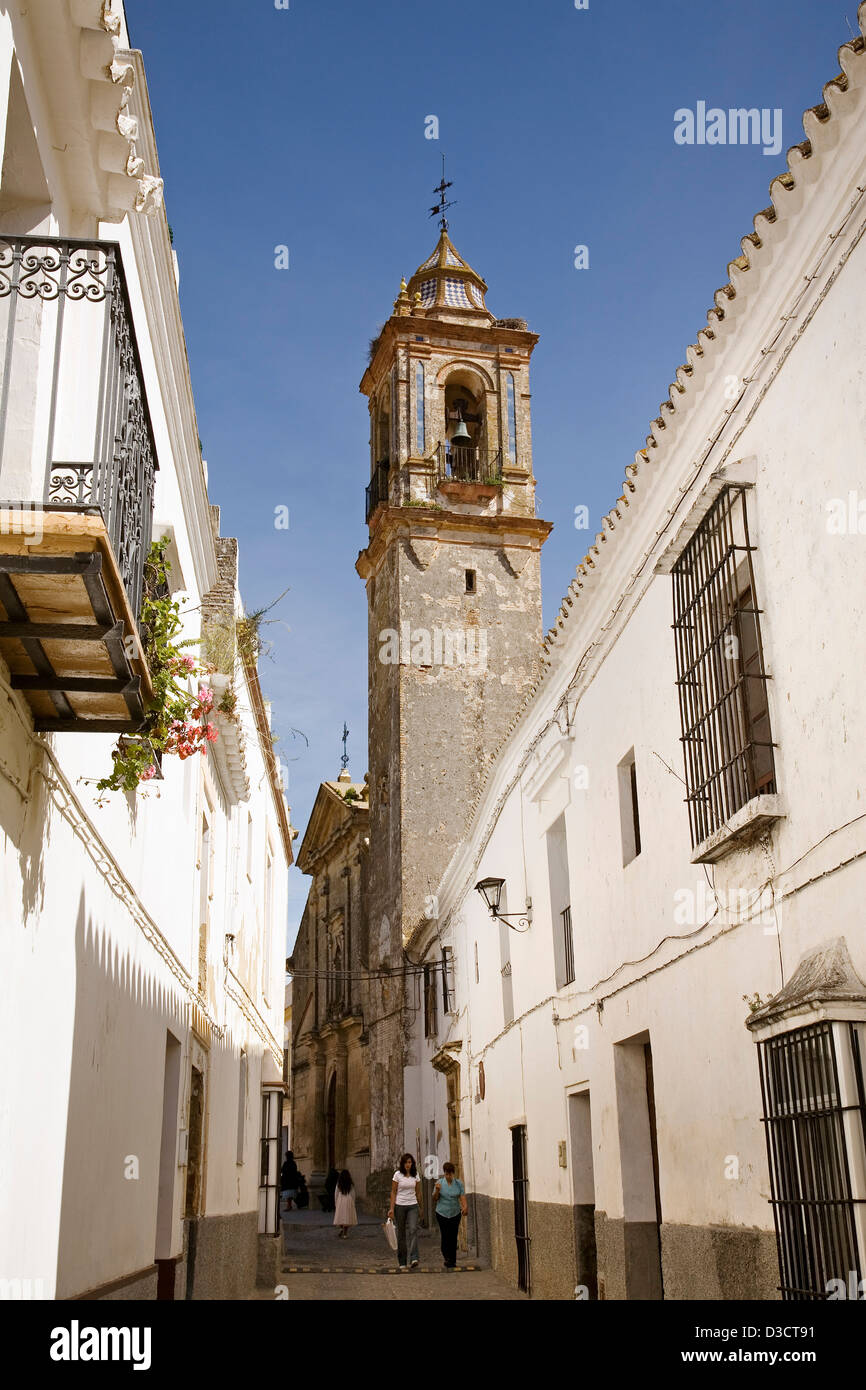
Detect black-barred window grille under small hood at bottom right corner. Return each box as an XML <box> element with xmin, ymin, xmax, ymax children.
<box><xmin>759</xmin><ymin>1022</ymin><xmax>866</xmax><ymax>1300</ymax></box>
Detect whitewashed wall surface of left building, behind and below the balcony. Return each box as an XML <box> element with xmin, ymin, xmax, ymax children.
<box><xmin>0</xmin><ymin>0</ymin><xmax>288</xmax><ymax>1297</ymax></box>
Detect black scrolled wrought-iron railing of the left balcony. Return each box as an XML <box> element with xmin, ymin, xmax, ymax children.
<box><xmin>0</xmin><ymin>235</ymin><xmax>157</xmax><ymax>620</ymax></box>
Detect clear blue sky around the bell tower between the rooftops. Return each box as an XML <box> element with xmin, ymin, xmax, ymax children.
<box><xmin>126</xmin><ymin>0</ymin><xmax>856</xmax><ymax>944</ymax></box>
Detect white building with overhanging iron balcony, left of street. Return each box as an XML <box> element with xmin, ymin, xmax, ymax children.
<box><xmin>0</xmin><ymin>0</ymin><xmax>292</xmax><ymax>1298</ymax></box>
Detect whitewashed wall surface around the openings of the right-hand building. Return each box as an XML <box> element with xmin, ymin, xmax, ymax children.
<box><xmin>406</xmin><ymin>7</ymin><xmax>866</xmax><ymax>1289</ymax></box>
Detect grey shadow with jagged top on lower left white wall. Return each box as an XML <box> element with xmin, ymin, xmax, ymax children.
<box><xmin>53</xmin><ymin>888</ymin><xmax>257</xmax><ymax>1298</ymax></box>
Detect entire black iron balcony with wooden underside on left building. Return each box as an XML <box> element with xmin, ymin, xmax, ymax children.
<box><xmin>0</xmin><ymin>235</ymin><xmax>157</xmax><ymax>733</ymax></box>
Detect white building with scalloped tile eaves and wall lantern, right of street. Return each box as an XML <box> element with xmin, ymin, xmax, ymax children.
<box><xmin>405</xmin><ymin>4</ymin><xmax>866</xmax><ymax>1298</ymax></box>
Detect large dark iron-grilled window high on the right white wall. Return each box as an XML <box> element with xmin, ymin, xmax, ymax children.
<box><xmin>673</xmin><ymin>487</ymin><xmax>776</xmax><ymax>847</ymax></box>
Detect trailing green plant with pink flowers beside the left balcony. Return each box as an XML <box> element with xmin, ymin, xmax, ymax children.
<box><xmin>97</xmin><ymin>539</ymin><xmax>218</xmax><ymax>792</ymax></box>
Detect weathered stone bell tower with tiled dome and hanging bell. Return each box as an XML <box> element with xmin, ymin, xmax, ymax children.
<box><xmin>357</xmin><ymin>218</ymin><xmax>552</xmax><ymax>1189</ymax></box>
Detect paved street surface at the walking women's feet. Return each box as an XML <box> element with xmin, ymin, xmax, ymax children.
<box><xmin>254</xmin><ymin>1211</ymin><xmax>525</xmax><ymax>1302</ymax></box>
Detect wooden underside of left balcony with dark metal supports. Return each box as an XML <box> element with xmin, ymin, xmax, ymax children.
<box><xmin>0</xmin><ymin>509</ymin><xmax>153</xmax><ymax>734</ymax></box>
